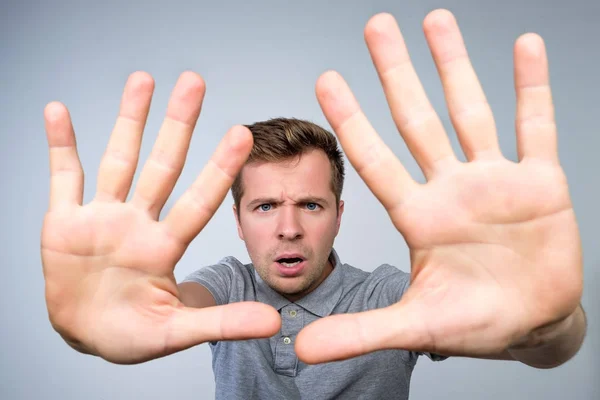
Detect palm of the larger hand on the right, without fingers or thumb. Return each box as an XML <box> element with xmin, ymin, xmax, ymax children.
<box><xmin>390</xmin><ymin>161</ymin><xmax>581</xmax><ymax>355</ymax></box>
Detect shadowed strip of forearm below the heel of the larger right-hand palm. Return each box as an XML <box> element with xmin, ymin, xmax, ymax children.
<box><xmin>508</xmin><ymin>305</ymin><xmax>587</xmax><ymax>368</ymax></box>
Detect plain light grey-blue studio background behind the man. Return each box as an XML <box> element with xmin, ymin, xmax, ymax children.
<box><xmin>0</xmin><ymin>0</ymin><xmax>600</xmax><ymax>399</ymax></box>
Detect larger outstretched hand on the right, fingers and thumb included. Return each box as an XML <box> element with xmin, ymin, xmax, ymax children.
<box><xmin>296</xmin><ymin>10</ymin><xmax>583</xmax><ymax>363</ymax></box>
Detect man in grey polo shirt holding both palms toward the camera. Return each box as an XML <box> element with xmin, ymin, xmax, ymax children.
<box><xmin>42</xmin><ymin>10</ymin><xmax>586</xmax><ymax>399</ymax></box>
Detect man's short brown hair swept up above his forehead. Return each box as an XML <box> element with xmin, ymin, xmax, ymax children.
<box><xmin>231</xmin><ymin>118</ymin><xmax>344</xmax><ymax>214</ymax></box>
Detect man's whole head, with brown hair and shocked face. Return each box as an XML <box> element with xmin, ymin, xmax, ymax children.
<box><xmin>231</xmin><ymin>118</ymin><xmax>344</xmax><ymax>300</ymax></box>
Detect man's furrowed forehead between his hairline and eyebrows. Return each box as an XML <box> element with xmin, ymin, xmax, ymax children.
<box><xmin>242</xmin><ymin>150</ymin><xmax>335</xmax><ymax>202</ymax></box>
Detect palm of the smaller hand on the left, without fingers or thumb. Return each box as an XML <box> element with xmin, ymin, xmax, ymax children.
<box><xmin>42</xmin><ymin>202</ymin><xmax>185</xmax><ymax>362</ymax></box>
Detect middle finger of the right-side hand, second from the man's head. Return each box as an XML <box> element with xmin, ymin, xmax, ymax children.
<box><xmin>365</xmin><ymin>14</ymin><xmax>456</xmax><ymax>178</ymax></box>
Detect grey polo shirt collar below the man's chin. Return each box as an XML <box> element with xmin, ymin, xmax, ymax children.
<box><xmin>254</xmin><ymin>249</ymin><xmax>343</xmax><ymax>317</ymax></box>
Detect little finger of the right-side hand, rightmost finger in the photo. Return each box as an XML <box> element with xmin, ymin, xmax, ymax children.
<box><xmin>515</xmin><ymin>33</ymin><xmax>558</xmax><ymax>163</ymax></box>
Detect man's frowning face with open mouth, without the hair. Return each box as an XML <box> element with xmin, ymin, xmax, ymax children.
<box><xmin>234</xmin><ymin>150</ymin><xmax>344</xmax><ymax>301</ymax></box>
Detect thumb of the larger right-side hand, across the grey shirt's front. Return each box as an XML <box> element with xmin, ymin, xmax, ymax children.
<box><xmin>295</xmin><ymin>303</ymin><xmax>428</xmax><ymax>364</ymax></box>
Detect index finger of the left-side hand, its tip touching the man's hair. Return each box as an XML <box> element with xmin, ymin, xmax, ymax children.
<box><xmin>161</xmin><ymin>126</ymin><xmax>253</xmax><ymax>243</ymax></box>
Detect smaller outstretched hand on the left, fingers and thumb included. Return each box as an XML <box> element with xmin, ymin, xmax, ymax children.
<box><xmin>41</xmin><ymin>72</ymin><xmax>280</xmax><ymax>364</ymax></box>
